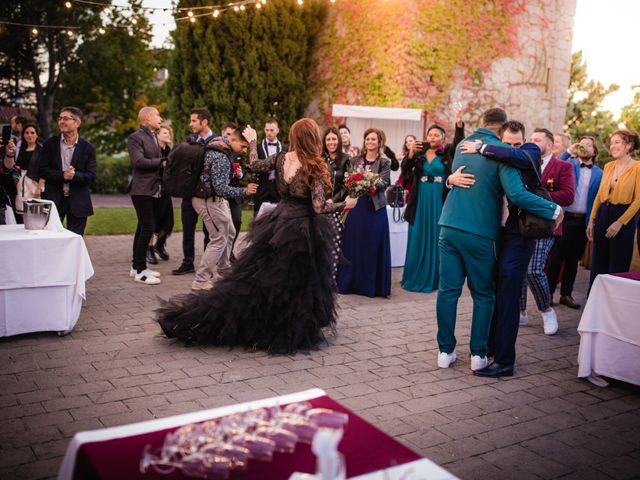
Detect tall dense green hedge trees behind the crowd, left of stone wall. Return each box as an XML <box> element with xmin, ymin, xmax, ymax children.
<box><xmin>168</xmin><ymin>0</ymin><xmax>327</xmax><ymax>139</ymax></box>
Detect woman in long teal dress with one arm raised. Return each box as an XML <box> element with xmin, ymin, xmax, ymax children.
<box><xmin>401</xmin><ymin>118</ymin><xmax>464</xmax><ymax>293</ymax></box>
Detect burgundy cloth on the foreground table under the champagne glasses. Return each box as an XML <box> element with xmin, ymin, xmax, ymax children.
<box><xmin>73</xmin><ymin>396</ymin><xmax>421</xmax><ymax>480</ymax></box>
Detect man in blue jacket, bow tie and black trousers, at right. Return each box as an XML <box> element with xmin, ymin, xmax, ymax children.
<box><xmin>548</xmin><ymin>137</ymin><xmax>602</xmax><ymax>309</ymax></box>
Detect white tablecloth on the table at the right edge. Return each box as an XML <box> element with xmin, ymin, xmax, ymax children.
<box><xmin>578</xmin><ymin>275</ymin><xmax>640</xmax><ymax>385</ymax></box>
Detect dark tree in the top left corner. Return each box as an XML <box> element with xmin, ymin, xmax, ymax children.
<box><xmin>0</xmin><ymin>0</ymin><xmax>100</xmax><ymax>137</ymax></box>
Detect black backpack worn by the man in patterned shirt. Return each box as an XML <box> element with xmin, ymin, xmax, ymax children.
<box><xmin>162</xmin><ymin>139</ymin><xmax>207</xmax><ymax>198</ymax></box>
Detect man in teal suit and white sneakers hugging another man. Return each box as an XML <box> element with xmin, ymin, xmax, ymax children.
<box><xmin>436</xmin><ymin>108</ymin><xmax>561</xmax><ymax>370</ymax></box>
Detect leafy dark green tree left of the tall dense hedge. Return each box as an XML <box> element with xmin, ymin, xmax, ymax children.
<box><xmin>56</xmin><ymin>7</ymin><xmax>166</xmax><ymax>153</ymax></box>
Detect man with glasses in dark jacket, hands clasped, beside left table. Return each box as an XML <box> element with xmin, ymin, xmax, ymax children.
<box><xmin>39</xmin><ymin>107</ymin><xmax>96</xmax><ymax>235</ymax></box>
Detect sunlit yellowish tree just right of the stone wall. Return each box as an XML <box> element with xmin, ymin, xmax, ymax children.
<box><xmin>565</xmin><ymin>51</ymin><xmax>619</xmax><ymax>159</ymax></box>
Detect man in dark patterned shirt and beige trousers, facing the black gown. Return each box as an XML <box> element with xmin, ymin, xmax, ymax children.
<box><xmin>191</xmin><ymin>129</ymin><xmax>258</xmax><ymax>290</ymax></box>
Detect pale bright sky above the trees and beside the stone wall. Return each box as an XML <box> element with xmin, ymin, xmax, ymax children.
<box><xmin>130</xmin><ymin>0</ymin><xmax>640</xmax><ymax>117</ymax></box>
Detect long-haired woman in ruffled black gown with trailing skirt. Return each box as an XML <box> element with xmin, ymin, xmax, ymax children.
<box><xmin>157</xmin><ymin>118</ymin><xmax>356</xmax><ymax>354</ymax></box>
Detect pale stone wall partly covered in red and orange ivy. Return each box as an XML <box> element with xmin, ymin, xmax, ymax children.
<box><xmin>308</xmin><ymin>0</ymin><xmax>576</xmax><ymax>133</ymax></box>
